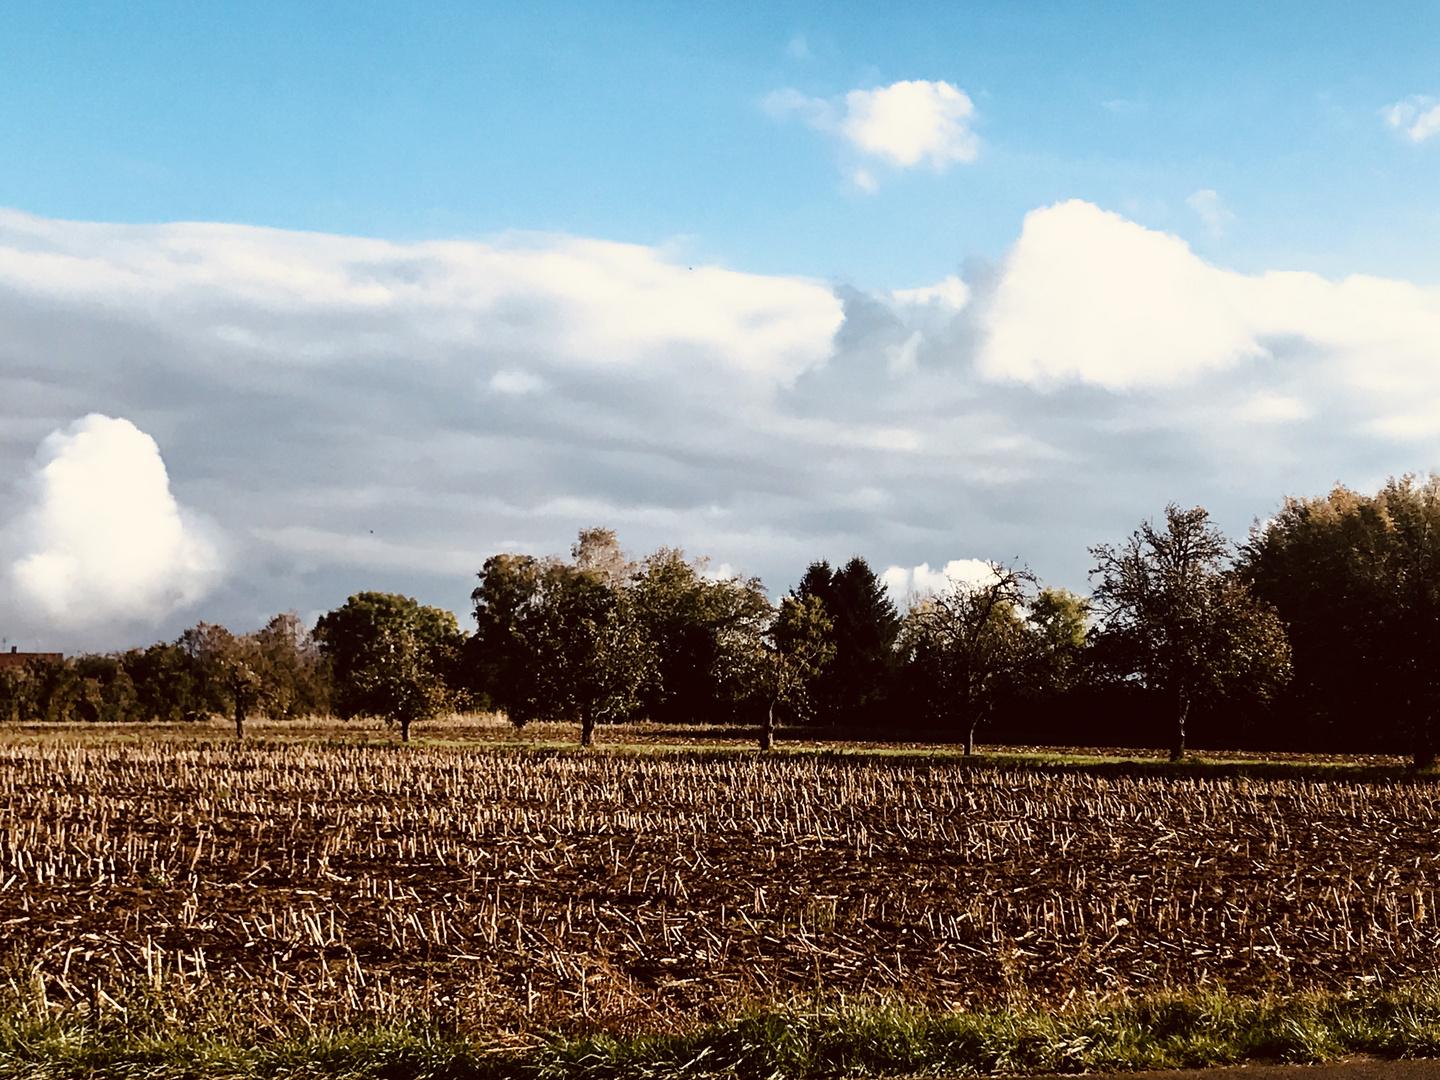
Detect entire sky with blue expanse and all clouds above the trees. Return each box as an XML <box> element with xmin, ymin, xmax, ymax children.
<box><xmin>0</xmin><ymin>3</ymin><xmax>1440</xmax><ymax>648</ymax></box>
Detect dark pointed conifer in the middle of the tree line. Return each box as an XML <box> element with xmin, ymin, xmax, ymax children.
<box><xmin>795</xmin><ymin>556</ymin><xmax>900</xmax><ymax>723</ymax></box>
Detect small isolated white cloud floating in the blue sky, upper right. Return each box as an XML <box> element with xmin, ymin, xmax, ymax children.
<box><xmin>763</xmin><ymin>79</ymin><xmax>979</xmax><ymax>192</ymax></box>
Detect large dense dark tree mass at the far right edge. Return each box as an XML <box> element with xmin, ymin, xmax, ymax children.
<box><xmin>1241</xmin><ymin>474</ymin><xmax>1440</xmax><ymax>766</ymax></box>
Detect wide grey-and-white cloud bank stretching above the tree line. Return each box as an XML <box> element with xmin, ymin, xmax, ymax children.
<box><xmin>0</xmin><ymin>202</ymin><xmax>1440</xmax><ymax>647</ymax></box>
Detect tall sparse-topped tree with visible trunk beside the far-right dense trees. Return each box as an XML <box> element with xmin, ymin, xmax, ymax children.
<box><xmin>1090</xmin><ymin>504</ymin><xmax>1290</xmax><ymax>760</ymax></box>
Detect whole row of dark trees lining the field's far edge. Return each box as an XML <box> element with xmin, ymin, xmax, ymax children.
<box><xmin>8</xmin><ymin>475</ymin><xmax>1440</xmax><ymax>765</ymax></box>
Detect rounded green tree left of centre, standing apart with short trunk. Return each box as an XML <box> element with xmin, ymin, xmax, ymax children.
<box><xmin>315</xmin><ymin>592</ymin><xmax>464</xmax><ymax>742</ymax></box>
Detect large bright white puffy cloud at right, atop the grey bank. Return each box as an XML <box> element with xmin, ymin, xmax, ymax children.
<box><xmin>981</xmin><ymin>202</ymin><xmax>1440</xmax><ymax>435</ymax></box>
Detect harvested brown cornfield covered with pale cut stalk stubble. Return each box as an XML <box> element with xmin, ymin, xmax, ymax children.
<box><xmin>0</xmin><ymin>742</ymin><xmax>1440</xmax><ymax>1031</ymax></box>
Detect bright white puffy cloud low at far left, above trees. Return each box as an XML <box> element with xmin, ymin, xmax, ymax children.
<box><xmin>10</xmin><ymin>413</ymin><xmax>220</xmax><ymax>628</ymax></box>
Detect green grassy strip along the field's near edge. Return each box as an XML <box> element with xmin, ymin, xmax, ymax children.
<box><xmin>0</xmin><ymin>981</ymin><xmax>1440</xmax><ymax>1080</ymax></box>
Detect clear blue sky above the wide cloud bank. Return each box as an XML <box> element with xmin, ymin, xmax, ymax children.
<box><xmin>11</xmin><ymin>3</ymin><xmax>1440</xmax><ymax>287</ymax></box>
